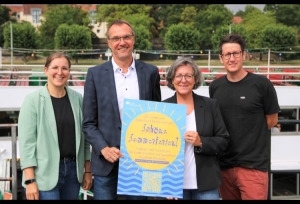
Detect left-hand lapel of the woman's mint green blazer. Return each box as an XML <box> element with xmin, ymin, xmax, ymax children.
<box><xmin>40</xmin><ymin>84</ymin><xmax>58</xmax><ymax>144</ymax></box>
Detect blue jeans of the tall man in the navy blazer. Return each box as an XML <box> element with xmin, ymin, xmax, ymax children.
<box><xmin>93</xmin><ymin>164</ymin><xmax>147</xmax><ymax>200</ymax></box>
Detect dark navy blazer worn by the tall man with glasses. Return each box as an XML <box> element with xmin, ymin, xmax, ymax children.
<box><xmin>82</xmin><ymin>60</ymin><xmax>161</xmax><ymax>176</ymax></box>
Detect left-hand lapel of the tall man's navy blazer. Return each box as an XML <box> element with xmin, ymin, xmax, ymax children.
<box><xmin>104</xmin><ymin>61</ymin><xmax>121</xmax><ymax>123</ymax></box>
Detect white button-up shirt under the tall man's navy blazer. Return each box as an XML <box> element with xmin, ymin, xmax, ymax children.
<box><xmin>112</xmin><ymin>58</ymin><xmax>140</xmax><ymax>120</ymax></box>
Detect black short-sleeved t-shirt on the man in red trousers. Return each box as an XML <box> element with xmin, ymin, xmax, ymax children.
<box><xmin>209</xmin><ymin>73</ymin><xmax>280</xmax><ymax>171</ymax></box>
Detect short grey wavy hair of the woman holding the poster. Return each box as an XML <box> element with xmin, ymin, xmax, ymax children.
<box><xmin>166</xmin><ymin>57</ymin><xmax>204</xmax><ymax>90</ymax></box>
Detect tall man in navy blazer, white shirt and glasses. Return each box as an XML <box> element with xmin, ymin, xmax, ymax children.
<box><xmin>83</xmin><ymin>20</ymin><xmax>161</xmax><ymax>200</ymax></box>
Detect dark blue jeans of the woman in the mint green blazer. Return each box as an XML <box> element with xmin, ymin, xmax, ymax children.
<box><xmin>26</xmin><ymin>158</ymin><xmax>80</xmax><ymax>200</ymax></box>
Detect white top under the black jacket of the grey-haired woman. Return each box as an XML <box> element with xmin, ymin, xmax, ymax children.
<box><xmin>183</xmin><ymin>111</ymin><xmax>198</xmax><ymax>189</ymax></box>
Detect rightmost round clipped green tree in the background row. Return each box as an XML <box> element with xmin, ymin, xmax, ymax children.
<box><xmin>260</xmin><ymin>25</ymin><xmax>297</xmax><ymax>49</ymax></box>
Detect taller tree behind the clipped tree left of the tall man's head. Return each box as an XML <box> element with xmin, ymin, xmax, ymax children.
<box><xmin>39</xmin><ymin>4</ymin><xmax>90</xmax><ymax>49</ymax></box>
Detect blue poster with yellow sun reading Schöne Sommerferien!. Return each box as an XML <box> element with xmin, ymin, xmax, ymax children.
<box><xmin>117</xmin><ymin>99</ymin><xmax>186</xmax><ymax>198</ymax></box>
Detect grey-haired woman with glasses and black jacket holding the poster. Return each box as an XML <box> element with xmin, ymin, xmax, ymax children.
<box><xmin>164</xmin><ymin>58</ymin><xmax>229</xmax><ymax>200</ymax></box>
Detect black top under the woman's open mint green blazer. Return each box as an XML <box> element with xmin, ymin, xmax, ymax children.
<box><xmin>51</xmin><ymin>93</ymin><xmax>76</xmax><ymax>158</ymax></box>
